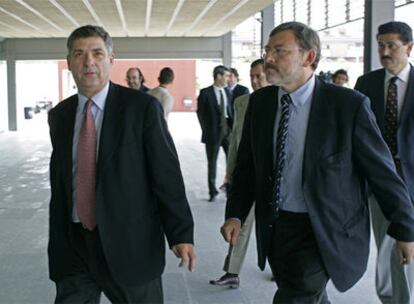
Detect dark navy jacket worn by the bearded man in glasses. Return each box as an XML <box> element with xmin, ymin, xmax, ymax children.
<box><xmin>226</xmin><ymin>80</ymin><xmax>414</xmax><ymax>291</ymax></box>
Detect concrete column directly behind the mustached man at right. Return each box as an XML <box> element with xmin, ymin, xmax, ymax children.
<box><xmin>364</xmin><ymin>0</ymin><xmax>394</xmax><ymax>73</ymax></box>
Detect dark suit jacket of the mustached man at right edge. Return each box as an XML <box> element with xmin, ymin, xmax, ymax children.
<box><xmin>355</xmin><ymin>66</ymin><xmax>414</xmax><ymax>201</ymax></box>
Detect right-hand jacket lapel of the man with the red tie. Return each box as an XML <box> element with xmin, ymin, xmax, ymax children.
<box><xmin>96</xmin><ymin>83</ymin><xmax>123</xmax><ymax>182</ymax></box>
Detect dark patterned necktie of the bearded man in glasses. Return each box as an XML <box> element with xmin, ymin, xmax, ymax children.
<box><xmin>271</xmin><ymin>94</ymin><xmax>292</xmax><ymax>215</ymax></box>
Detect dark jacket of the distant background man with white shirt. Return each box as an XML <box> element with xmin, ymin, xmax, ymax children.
<box><xmin>197</xmin><ymin>86</ymin><xmax>233</xmax><ymax>144</ymax></box>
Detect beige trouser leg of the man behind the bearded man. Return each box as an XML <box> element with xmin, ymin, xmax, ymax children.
<box><xmin>223</xmin><ymin>204</ymin><xmax>254</xmax><ymax>274</ymax></box>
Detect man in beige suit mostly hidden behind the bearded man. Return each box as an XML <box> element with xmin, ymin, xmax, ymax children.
<box><xmin>210</xmin><ymin>59</ymin><xmax>269</xmax><ymax>288</ymax></box>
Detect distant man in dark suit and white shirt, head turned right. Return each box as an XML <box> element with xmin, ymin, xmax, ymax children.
<box><xmin>197</xmin><ymin>65</ymin><xmax>233</xmax><ymax>202</ymax></box>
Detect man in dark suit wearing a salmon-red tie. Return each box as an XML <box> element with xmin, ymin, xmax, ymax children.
<box><xmin>48</xmin><ymin>25</ymin><xmax>195</xmax><ymax>303</ymax></box>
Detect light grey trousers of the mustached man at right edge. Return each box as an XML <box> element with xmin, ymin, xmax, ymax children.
<box><xmin>369</xmin><ymin>195</ymin><xmax>414</xmax><ymax>304</ymax></box>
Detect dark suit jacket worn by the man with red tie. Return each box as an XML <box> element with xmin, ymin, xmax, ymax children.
<box><xmin>48</xmin><ymin>83</ymin><xmax>193</xmax><ymax>285</ymax></box>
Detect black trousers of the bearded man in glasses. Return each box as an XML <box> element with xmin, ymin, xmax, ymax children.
<box><xmin>268</xmin><ymin>210</ymin><xmax>329</xmax><ymax>304</ymax></box>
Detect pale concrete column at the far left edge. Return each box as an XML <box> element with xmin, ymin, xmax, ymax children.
<box><xmin>6</xmin><ymin>49</ymin><xmax>17</xmax><ymax>131</ymax></box>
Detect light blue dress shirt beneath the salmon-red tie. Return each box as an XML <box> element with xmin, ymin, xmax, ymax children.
<box><xmin>72</xmin><ymin>82</ymin><xmax>109</xmax><ymax>223</ymax></box>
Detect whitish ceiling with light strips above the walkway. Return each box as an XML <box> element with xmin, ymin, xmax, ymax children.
<box><xmin>0</xmin><ymin>0</ymin><xmax>275</xmax><ymax>39</ymax></box>
